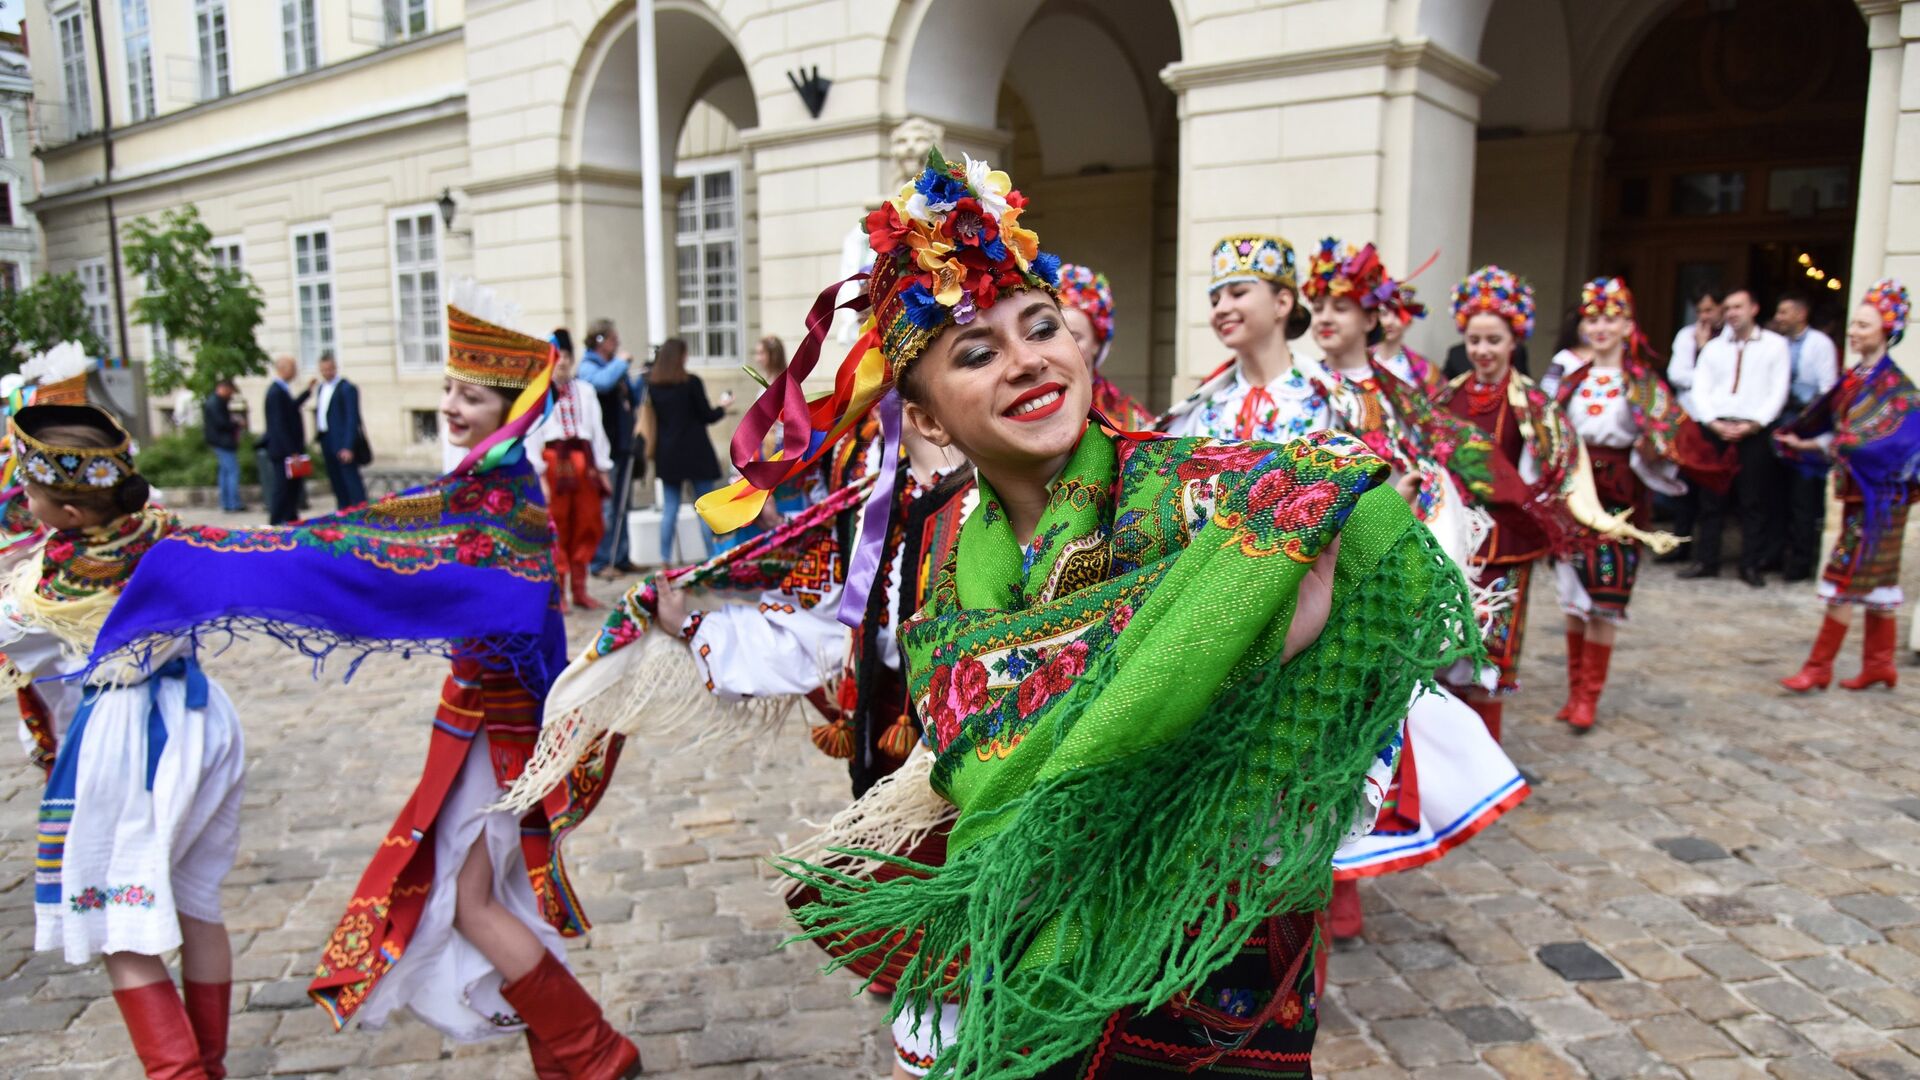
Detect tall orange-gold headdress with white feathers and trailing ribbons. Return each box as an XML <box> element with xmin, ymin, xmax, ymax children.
<box><xmin>445</xmin><ymin>281</ymin><xmax>559</xmax><ymax>473</ymax></box>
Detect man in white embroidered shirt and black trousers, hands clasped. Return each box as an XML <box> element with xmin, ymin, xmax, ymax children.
<box><xmin>1680</xmin><ymin>288</ymin><xmax>1793</xmax><ymax>588</ymax></box>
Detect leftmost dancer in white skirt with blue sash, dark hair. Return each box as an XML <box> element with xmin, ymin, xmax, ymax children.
<box><xmin>0</xmin><ymin>405</ymin><xmax>246</xmax><ymax>1080</ymax></box>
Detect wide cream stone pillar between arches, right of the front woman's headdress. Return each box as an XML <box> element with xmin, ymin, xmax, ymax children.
<box><xmin>1162</xmin><ymin>34</ymin><xmax>1494</xmax><ymax>400</ymax></box>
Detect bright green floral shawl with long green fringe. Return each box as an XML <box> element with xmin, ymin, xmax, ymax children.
<box><xmin>787</xmin><ymin>427</ymin><xmax>1478</xmax><ymax>1078</ymax></box>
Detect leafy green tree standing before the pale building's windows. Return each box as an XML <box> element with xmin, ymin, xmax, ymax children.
<box><xmin>125</xmin><ymin>204</ymin><xmax>267</xmax><ymax>398</ymax></box>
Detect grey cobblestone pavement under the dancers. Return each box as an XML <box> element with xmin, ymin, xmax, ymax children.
<box><xmin>0</xmin><ymin>507</ymin><xmax>1920</xmax><ymax>1080</ymax></box>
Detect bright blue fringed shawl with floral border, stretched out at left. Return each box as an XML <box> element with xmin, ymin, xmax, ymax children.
<box><xmin>92</xmin><ymin>459</ymin><xmax>566</xmax><ymax>694</ymax></box>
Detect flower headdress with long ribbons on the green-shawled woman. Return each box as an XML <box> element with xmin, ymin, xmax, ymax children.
<box><xmin>695</xmin><ymin>148</ymin><xmax>1060</xmax><ymax>625</ymax></box>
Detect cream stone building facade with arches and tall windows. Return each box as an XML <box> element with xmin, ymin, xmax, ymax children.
<box><xmin>18</xmin><ymin>0</ymin><xmax>1920</xmax><ymax>457</ymax></box>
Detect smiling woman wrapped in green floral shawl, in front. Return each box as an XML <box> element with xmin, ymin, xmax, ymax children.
<box><xmin>703</xmin><ymin>152</ymin><xmax>1473</xmax><ymax>1078</ymax></box>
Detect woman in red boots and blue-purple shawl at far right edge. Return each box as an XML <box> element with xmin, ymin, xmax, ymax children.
<box><xmin>1774</xmin><ymin>279</ymin><xmax>1920</xmax><ymax>694</ymax></box>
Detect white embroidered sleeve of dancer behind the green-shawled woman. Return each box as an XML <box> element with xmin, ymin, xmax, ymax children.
<box><xmin>687</xmin><ymin>584</ymin><xmax>847</xmax><ymax>701</ymax></box>
